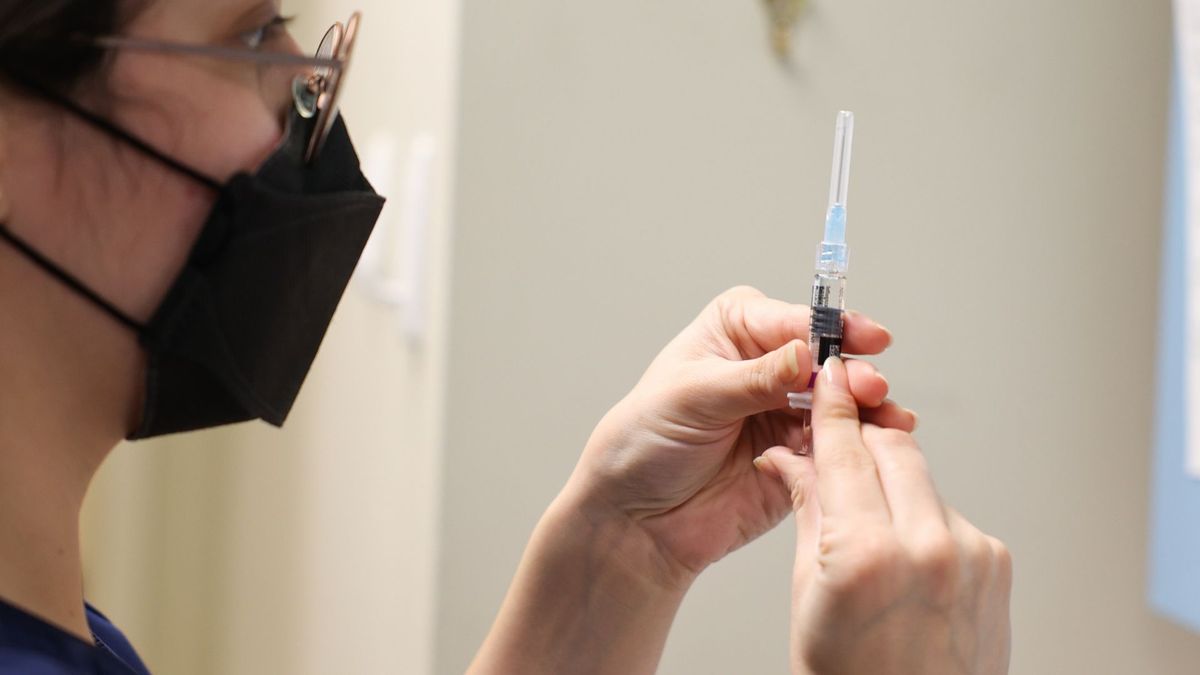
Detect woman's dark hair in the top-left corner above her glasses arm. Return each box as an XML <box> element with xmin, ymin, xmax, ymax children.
<box><xmin>0</xmin><ymin>0</ymin><xmax>130</xmax><ymax>91</ymax></box>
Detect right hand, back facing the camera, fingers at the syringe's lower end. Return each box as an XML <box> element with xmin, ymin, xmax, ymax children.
<box><xmin>757</xmin><ymin>359</ymin><xmax>1012</xmax><ymax>675</ymax></box>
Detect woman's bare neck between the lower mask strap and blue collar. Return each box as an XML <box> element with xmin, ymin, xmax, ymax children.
<box><xmin>0</xmin><ymin>239</ymin><xmax>138</xmax><ymax>641</ymax></box>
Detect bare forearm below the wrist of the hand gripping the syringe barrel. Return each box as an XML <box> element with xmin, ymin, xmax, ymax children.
<box><xmin>468</xmin><ymin>480</ymin><xmax>690</xmax><ymax>675</ymax></box>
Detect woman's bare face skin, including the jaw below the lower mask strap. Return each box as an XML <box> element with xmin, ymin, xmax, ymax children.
<box><xmin>0</xmin><ymin>0</ymin><xmax>312</xmax><ymax>441</ymax></box>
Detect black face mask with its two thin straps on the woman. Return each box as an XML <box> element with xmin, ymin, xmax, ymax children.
<box><xmin>0</xmin><ymin>79</ymin><xmax>384</xmax><ymax>440</ymax></box>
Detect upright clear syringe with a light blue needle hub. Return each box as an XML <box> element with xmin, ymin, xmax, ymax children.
<box><xmin>787</xmin><ymin>110</ymin><xmax>854</xmax><ymax>437</ymax></box>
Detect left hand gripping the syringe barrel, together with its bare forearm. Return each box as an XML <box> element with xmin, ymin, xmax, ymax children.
<box><xmin>469</xmin><ymin>283</ymin><xmax>916</xmax><ymax>675</ymax></box>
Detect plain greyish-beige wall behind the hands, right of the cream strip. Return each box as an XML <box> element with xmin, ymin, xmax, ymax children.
<box><xmin>436</xmin><ymin>0</ymin><xmax>1200</xmax><ymax>675</ymax></box>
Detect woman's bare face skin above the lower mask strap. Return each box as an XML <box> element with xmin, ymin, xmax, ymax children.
<box><xmin>0</xmin><ymin>0</ymin><xmax>299</xmax><ymax>322</ymax></box>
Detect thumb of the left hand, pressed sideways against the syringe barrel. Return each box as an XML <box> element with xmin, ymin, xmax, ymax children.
<box><xmin>692</xmin><ymin>340</ymin><xmax>812</xmax><ymax>423</ymax></box>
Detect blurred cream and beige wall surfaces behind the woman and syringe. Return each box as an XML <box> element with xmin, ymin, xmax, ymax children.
<box><xmin>75</xmin><ymin>0</ymin><xmax>1200</xmax><ymax>675</ymax></box>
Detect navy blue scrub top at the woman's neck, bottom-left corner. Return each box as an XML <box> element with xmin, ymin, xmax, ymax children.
<box><xmin>0</xmin><ymin>601</ymin><xmax>150</xmax><ymax>675</ymax></box>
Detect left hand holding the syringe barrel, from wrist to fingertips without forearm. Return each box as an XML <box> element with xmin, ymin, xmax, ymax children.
<box><xmin>556</xmin><ymin>288</ymin><xmax>916</xmax><ymax>586</ymax></box>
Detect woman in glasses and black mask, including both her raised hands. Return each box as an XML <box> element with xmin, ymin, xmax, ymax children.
<box><xmin>0</xmin><ymin>0</ymin><xmax>1010</xmax><ymax>675</ymax></box>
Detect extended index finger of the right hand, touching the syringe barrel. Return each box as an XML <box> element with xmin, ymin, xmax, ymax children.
<box><xmin>812</xmin><ymin>357</ymin><xmax>892</xmax><ymax>521</ymax></box>
